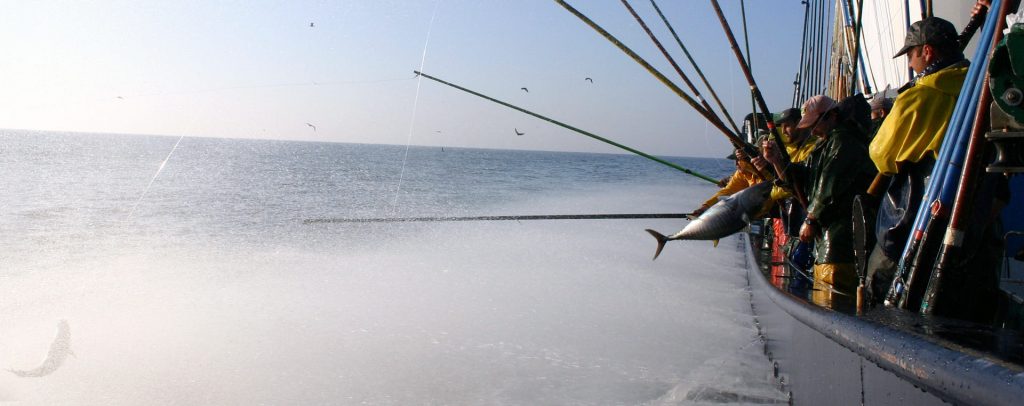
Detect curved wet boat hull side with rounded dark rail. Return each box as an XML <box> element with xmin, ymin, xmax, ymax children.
<box><xmin>743</xmin><ymin>235</ymin><xmax>1024</xmax><ymax>405</ymax></box>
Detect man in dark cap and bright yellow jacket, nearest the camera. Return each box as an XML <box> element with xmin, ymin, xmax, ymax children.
<box><xmin>867</xmin><ymin>14</ymin><xmax>983</xmax><ymax>302</ymax></box>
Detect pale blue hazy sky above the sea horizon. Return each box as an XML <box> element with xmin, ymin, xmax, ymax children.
<box><xmin>0</xmin><ymin>0</ymin><xmax>803</xmax><ymax>157</ymax></box>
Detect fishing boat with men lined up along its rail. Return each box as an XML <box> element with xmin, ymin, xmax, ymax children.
<box><xmin>744</xmin><ymin>1</ymin><xmax>1024</xmax><ymax>405</ymax></box>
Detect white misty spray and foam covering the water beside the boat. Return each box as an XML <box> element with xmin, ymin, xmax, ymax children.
<box><xmin>0</xmin><ymin>182</ymin><xmax>775</xmax><ymax>405</ymax></box>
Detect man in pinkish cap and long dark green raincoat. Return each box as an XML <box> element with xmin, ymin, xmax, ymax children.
<box><xmin>764</xmin><ymin>95</ymin><xmax>874</xmax><ymax>293</ymax></box>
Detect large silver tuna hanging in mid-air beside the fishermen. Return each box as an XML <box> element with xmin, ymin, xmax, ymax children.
<box><xmin>647</xmin><ymin>181</ymin><xmax>772</xmax><ymax>259</ymax></box>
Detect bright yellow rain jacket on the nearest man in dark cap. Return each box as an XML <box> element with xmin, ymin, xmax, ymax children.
<box><xmin>868</xmin><ymin>67</ymin><xmax>968</xmax><ymax>175</ymax></box>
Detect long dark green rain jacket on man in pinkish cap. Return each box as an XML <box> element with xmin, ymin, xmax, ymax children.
<box><xmin>792</xmin><ymin>122</ymin><xmax>876</xmax><ymax>263</ymax></box>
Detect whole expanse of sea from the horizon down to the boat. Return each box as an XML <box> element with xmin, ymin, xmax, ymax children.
<box><xmin>0</xmin><ymin>131</ymin><xmax>785</xmax><ymax>405</ymax></box>
